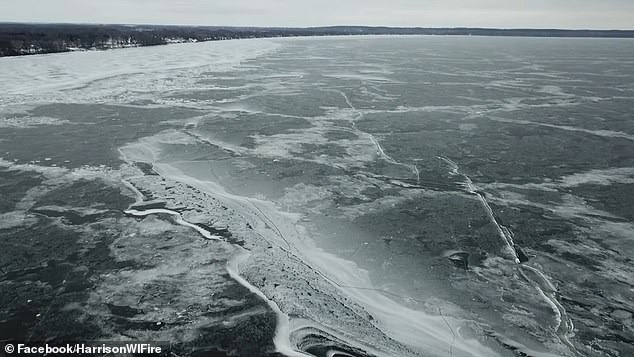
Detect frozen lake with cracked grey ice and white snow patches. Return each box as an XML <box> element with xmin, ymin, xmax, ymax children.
<box><xmin>0</xmin><ymin>36</ymin><xmax>634</xmax><ymax>357</ymax></box>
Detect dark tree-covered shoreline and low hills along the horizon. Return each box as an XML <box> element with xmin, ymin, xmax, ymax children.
<box><xmin>0</xmin><ymin>23</ymin><xmax>634</xmax><ymax>57</ymax></box>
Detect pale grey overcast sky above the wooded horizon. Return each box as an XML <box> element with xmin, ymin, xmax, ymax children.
<box><xmin>0</xmin><ymin>0</ymin><xmax>634</xmax><ymax>29</ymax></box>
